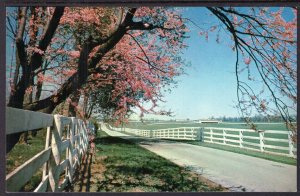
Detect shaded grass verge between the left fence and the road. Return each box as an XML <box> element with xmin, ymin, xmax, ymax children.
<box><xmin>68</xmin><ymin>131</ymin><xmax>227</xmax><ymax>192</ymax></box>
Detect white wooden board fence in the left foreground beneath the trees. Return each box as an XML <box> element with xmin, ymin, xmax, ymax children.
<box><xmin>6</xmin><ymin>108</ymin><xmax>92</xmax><ymax>192</ymax></box>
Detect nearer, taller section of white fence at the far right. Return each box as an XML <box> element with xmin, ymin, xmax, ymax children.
<box><xmin>203</xmin><ymin>127</ymin><xmax>297</xmax><ymax>158</ymax></box>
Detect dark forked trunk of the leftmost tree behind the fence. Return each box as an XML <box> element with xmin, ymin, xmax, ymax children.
<box><xmin>6</xmin><ymin>7</ymin><xmax>64</xmax><ymax>152</ymax></box>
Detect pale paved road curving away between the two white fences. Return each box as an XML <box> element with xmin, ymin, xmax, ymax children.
<box><xmin>105</xmin><ymin>125</ymin><xmax>297</xmax><ymax>192</ymax></box>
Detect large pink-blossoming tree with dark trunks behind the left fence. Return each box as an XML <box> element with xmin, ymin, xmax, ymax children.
<box><xmin>8</xmin><ymin>7</ymin><xmax>187</xmax><ymax>150</ymax></box>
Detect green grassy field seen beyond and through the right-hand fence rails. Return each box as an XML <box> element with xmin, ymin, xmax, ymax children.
<box><xmin>118</xmin><ymin>121</ymin><xmax>297</xmax><ymax>165</ymax></box>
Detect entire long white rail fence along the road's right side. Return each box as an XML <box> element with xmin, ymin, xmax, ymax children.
<box><xmin>111</xmin><ymin>127</ymin><xmax>297</xmax><ymax>158</ymax></box>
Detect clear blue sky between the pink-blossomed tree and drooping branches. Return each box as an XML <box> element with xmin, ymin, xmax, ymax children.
<box><xmin>6</xmin><ymin>7</ymin><xmax>296</xmax><ymax>119</ymax></box>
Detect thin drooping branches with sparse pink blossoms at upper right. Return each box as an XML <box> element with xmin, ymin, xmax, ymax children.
<box><xmin>208</xmin><ymin>7</ymin><xmax>297</xmax><ymax>138</ymax></box>
